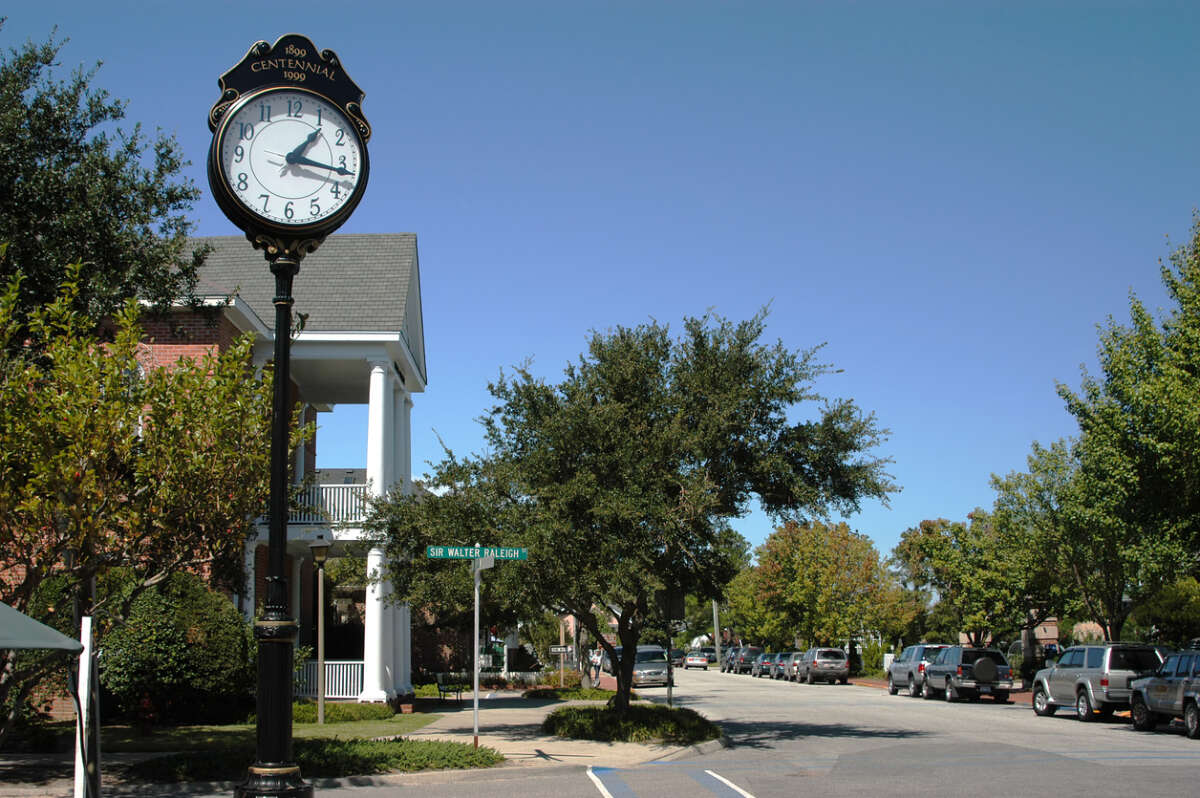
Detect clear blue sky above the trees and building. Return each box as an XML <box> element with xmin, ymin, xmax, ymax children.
<box><xmin>0</xmin><ymin>0</ymin><xmax>1200</xmax><ymax>553</ymax></box>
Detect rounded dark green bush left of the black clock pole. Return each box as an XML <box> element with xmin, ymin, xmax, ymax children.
<box><xmin>100</xmin><ymin>574</ymin><xmax>256</xmax><ymax>722</ymax></box>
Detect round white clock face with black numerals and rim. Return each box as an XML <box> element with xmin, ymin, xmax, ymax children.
<box><xmin>214</xmin><ymin>89</ymin><xmax>366</xmax><ymax>227</ymax></box>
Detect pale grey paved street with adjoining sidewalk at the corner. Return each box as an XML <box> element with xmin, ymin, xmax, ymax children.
<box><xmin>0</xmin><ymin>670</ymin><xmax>1200</xmax><ymax>798</ymax></box>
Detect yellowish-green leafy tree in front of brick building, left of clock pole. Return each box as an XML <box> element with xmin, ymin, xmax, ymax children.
<box><xmin>0</xmin><ymin>269</ymin><xmax>285</xmax><ymax>734</ymax></box>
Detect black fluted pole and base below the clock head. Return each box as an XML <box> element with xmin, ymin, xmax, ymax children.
<box><xmin>234</xmin><ymin>253</ymin><xmax>312</xmax><ymax>798</ymax></box>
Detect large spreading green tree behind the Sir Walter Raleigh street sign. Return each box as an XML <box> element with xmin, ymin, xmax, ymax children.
<box><xmin>370</xmin><ymin>313</ymin><xmax>894</xmax><ymax>712</ymax></box>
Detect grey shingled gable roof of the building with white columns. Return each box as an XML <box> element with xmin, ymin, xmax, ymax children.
<box><xmin>190</xmin><ymin>233</ymin><xmax>426</xmax><ymax>380</ymax></box>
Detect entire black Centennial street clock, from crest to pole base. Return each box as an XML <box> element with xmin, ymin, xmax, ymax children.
<box><xmin>209</xmin><ymin>34</ymin><xmax>371</xmax><ymax>798</ymax></box>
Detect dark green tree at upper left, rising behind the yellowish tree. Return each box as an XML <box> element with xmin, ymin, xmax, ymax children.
<box><xmin>0</xmin><ymin>18</ymin><xmax>203</xmax><ymax>320</ymax></box>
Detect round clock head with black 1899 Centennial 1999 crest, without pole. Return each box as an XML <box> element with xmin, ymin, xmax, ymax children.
<box><xmin>209</xmin><ymin>34</ymin><xmax>371</xmax><ymax>257</ymax></box>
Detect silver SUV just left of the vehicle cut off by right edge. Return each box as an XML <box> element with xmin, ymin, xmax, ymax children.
<box><xmin>1033</xmin><ymin>643</ymin><xmax>1163</xmax><ymax>721</ymax></box>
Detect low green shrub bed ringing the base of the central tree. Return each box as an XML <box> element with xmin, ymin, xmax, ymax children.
<box><xmin>541</xmin><ymin>704</ymin><xmax>721</xmax><ymax>745</ymax></box>
